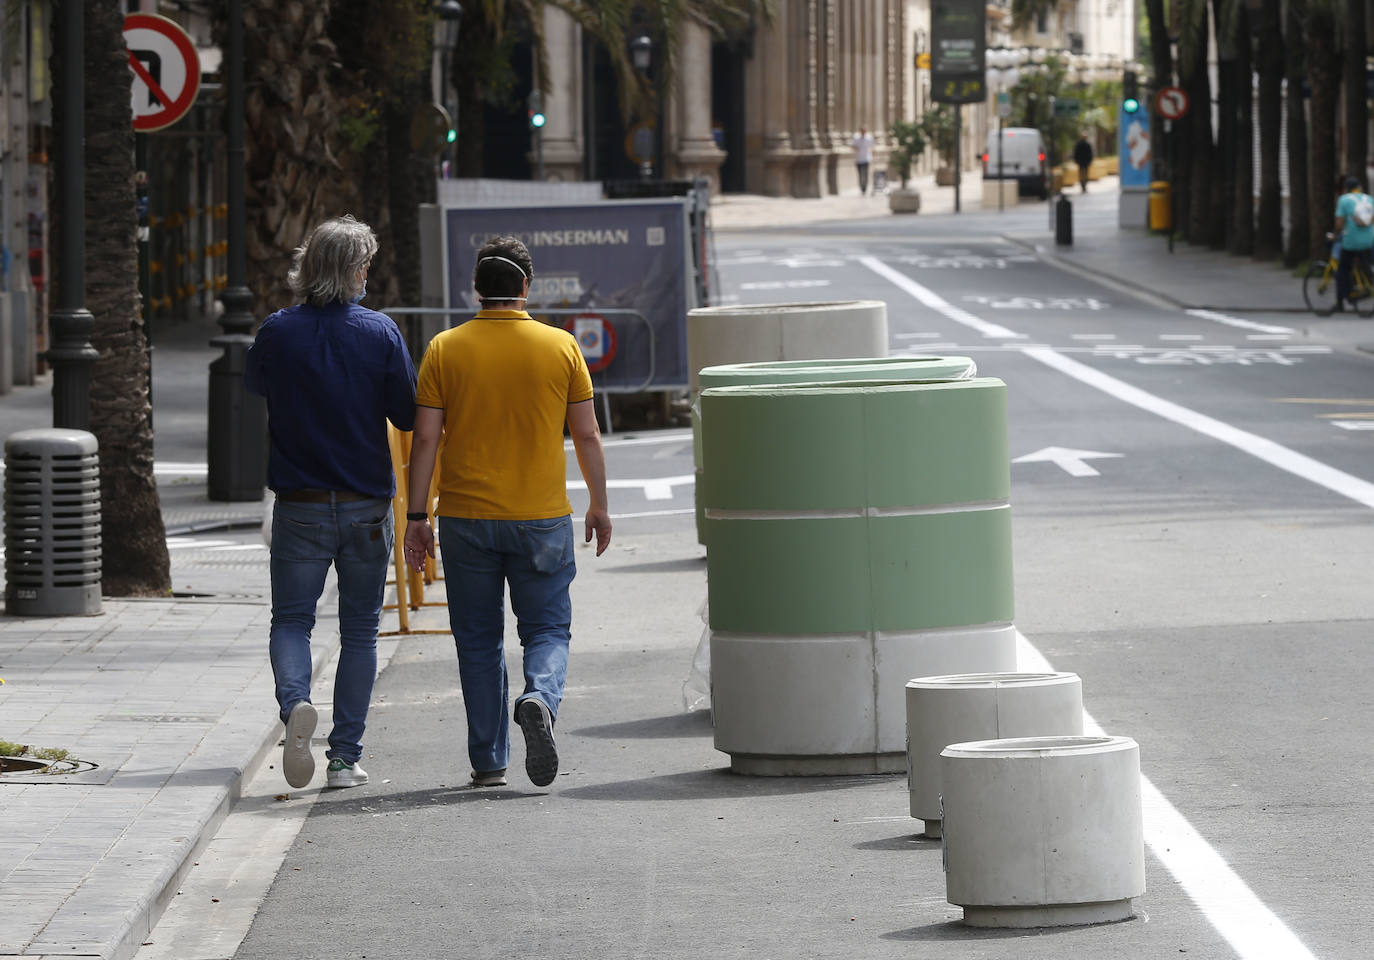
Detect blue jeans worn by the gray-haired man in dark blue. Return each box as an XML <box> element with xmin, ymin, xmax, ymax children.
<box><xmin>268</xmin><ymin>500</ymin><xmax>393</xmax><ymax>764</ymax></box>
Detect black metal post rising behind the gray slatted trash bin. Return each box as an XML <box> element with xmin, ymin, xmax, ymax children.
<box><xmin>45</xmin><ymin>0</ymin><xmax>100</xmax><ymax>430</ymax></box>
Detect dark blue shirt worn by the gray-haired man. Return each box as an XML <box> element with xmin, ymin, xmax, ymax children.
<box><xmin>243</xmin><ymin>304</ymin><xmax>415</xmax><ymax>499</ymax></box>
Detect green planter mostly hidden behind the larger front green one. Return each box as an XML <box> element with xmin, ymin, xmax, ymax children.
<box><xmin>691</xmin><ymin>357</ymin><xmax>978</xmax><ymax>545</ymax></box>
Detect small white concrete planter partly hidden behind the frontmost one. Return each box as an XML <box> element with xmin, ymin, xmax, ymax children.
<box><xmin>907</xmin><ymin>673</ymin><xmax>1083</xmax><ymax>836</ymax></box>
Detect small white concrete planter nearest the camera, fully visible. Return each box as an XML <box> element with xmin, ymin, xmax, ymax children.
<box><xmin>940</xmin><ymin>736</ymin><xmax>1145</xmax><ymax>927</ymax></box>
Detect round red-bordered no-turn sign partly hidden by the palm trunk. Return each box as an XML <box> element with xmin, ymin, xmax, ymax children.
<box><xmin>124</xmin><ymin>14</ymin><xmax>201</xmax><ymax>133</ymax></box>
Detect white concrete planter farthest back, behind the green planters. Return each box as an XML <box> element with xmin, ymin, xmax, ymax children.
<box><xmin>687</xmin><ymin>299</ymin><xmax>888</xmax><ymax>397</ymax></box>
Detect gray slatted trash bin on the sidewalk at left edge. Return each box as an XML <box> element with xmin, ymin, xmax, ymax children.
<box><xmin>4</xmin><ymin>428</ymin><xmax>100</xmax><ymax>617</ymax></box>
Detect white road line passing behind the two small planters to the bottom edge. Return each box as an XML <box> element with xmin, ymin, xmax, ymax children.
<box><xmin>1017</xmin><ymin>630</ymin><xmax>1316</xmax><ymax>960</ymax></box>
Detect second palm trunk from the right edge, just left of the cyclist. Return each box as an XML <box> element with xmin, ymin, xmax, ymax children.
<box><xmin>1303</xmin><ymin>0</ymin><xmax>1341</xmax><ymax>258</ymax></box>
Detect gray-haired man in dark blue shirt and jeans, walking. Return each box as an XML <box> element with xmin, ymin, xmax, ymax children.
<box><xmin>243</xmin><ymin>217</ymin><xmax>415</xmax><ymax>787</ymax></box>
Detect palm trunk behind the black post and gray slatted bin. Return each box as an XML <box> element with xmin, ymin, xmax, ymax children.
<box><xmin>52</xmin><ymin>0</ymin><xmax>172</xmax><ymax>596</ymax></box>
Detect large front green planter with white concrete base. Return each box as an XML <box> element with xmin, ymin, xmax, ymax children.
<box><xmin>701</xmin><ymin>378</ymin><xmax>1015</xmax><ymax>775</ymax></box>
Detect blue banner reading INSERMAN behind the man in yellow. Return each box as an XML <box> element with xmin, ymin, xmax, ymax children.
<box><xmin>444</xmin><ymin>198</ymin><xmax>695</xmax><ymax>391</ymax></box>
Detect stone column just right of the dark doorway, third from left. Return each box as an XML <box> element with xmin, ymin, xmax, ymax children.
<box><xmin>745</xmin><ymin>4</ymin><xmax>793</xmax><ymax>196</ymax></box>
